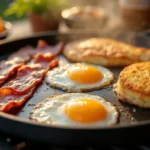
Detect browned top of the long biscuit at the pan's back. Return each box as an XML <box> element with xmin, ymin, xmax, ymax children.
<box><xmin>64</xmin><ymin>38</ymin><xmax>150</xmax><ymax>61</ymax></box>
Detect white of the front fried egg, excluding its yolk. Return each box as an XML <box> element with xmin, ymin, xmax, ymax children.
<box><xmin>30</xmin><ymin>93</ymin><xmax>119</xmax><ymax>127</ymax></box>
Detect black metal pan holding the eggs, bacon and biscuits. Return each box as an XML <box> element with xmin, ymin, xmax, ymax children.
<box><xmin>0</xmin><ymin>32</ymin><xmax>150</xmax><ymax>145</ymax></box>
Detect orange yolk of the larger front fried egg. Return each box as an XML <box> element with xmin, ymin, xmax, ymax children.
<box><xmin>64</xmin><ymin>98</ymin><xmax>107</xmax><ymax>123</ymax></box>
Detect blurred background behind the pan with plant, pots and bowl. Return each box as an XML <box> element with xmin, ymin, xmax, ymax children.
<box><xmin>0</xmin><ymin>0</ymin><xmax>150</xmax><ymax>43</ymax></box>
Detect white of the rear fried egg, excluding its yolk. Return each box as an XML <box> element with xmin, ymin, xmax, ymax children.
<box><xmin>45</xmin><ymin>63</ymin><xmax>114</xmax><ymax>92</ymax></box>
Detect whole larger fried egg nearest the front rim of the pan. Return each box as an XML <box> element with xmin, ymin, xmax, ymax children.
<box><xmin>30</xmin><ymin>93</ymin><xmax>119</xmax><ymax>127</ymax></box>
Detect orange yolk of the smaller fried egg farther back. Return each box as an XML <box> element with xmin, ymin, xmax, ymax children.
<box><xmin>68</xmin><ymin>66</ymin><xmax>103</xmax><ymax>84</ymax></box>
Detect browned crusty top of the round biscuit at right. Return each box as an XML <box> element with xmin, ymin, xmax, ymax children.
<box><xmin>119</xmin><ymin>62</ymin><xmax>150</xmax><ymax>96</ymax></box>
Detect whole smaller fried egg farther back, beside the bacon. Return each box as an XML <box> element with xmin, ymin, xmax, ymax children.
<box><xmin>45</xmin><ymin>63</ymin><xmax>114</xmax><ymax>92</ymax></box>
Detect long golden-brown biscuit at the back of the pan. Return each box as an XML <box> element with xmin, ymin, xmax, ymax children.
<box><xmin>63</xmin><ymin>38</ymin><xmax>150</xmax><ymax>67</ymax></box>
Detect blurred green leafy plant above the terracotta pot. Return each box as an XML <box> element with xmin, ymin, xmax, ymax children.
<box><xmin>4</xmin><ymin>0</ymin><xmax>68</xmax><ymax>17</ymax></box>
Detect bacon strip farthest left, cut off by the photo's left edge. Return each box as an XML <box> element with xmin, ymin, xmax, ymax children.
<box><xmin>0</xmin><ymin>46</ymin><xmax>34</xmax><ymax>85</ymax></box>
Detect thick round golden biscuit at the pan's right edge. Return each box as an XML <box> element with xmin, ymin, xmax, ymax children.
<box><xmin>114</xmin><ymin>62</ymin><xmax>150</xmax><ymax>108</ymax></box>
